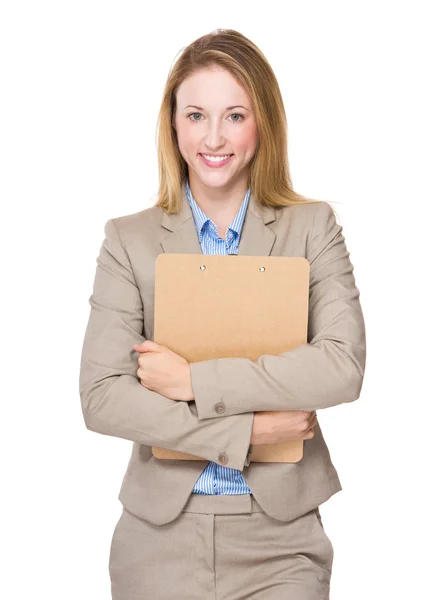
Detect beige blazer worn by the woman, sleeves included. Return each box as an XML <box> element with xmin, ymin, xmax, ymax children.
<box><xmin>79</xmin><ymin>185</ymin><xmax>366</xmax><ymax>525</ymax></box>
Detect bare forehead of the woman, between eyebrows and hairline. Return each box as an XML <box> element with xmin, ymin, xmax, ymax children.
<box><xmin>176</xmin><ymin>67</ymin><xmax>250</xmax><ymax>109</ymax></box>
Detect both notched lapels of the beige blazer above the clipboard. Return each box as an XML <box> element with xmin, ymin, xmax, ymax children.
<box><xmin>160</xmin><ymin>183</ymin><xmax>276</xmax><ymax>256</ymax></box>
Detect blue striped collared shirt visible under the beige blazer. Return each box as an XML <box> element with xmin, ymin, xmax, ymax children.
<box><xmin>185</xmin><ymin>180</ymin><xmax>252</xmax><ymax>495</ymax></box>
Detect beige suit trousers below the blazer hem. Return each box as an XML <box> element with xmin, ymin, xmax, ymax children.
<box><xmin>109</xmin><ymin>494</ymin><xmax>333</xmax><ymax>600</ymax></box>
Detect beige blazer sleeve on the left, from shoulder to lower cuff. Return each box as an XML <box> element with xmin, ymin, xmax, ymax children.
<box><xmin>79</xmin><ymin>219</ymin><xmax>254</xmax><ymax>470</ymax></box>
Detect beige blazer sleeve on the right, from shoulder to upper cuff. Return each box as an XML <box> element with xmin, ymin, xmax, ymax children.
<box><xmin>190</xmin><ymin>201</ymin><xmax>366</xmax><ymax>421</ymax></box>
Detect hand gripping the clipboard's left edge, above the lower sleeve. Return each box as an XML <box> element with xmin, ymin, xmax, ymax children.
<box><xmin>133</xmin><ymin>340</ymin><xmax>195</xmax><ymax>401</ymax></box>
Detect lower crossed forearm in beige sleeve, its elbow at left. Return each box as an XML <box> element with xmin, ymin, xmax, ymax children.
<box><xmin>80</xmin><ymin>363</ymin><xmax>253</xmax><ymax>470</ymax></box>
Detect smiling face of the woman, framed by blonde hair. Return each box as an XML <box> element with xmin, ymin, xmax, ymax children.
<box><xmin>173</xmin><ymin>66</ymin><xmax>258</xmax><ymax>189</ymax></box>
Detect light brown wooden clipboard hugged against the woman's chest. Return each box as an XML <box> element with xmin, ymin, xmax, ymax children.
<box><xmin>152</xmin><ymin>253</ymin><xmax>310</xmax><ymax>463</ymax></box>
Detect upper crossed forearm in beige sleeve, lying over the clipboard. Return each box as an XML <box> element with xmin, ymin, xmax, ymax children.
<box><xmin>191</xmin><ymin>341</ymin><xmax>363</xmax><ymax>420</ymax></box>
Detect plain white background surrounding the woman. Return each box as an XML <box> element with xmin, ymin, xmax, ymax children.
<box><xmin>0</xmin><ymin>0</ymin><xmax>442</xmax><ymax>600</ymax></box>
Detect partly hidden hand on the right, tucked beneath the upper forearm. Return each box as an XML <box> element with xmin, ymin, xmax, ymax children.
<box><xmin>250</xmin><ymin>410</ymin><xmax>318</xmax><ymax>445</ymax></box>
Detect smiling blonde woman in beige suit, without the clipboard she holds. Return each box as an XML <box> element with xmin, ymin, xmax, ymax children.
<box><xmin>80</xmin><ymin>30</ymin><xmax>365</xmax><ymax>600</ymax></box>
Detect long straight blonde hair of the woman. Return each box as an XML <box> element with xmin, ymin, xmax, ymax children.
<box><xmin>155</xmin><ymin>29</ymin><xmax>318</xmax><ymax>214</ymax></box>
